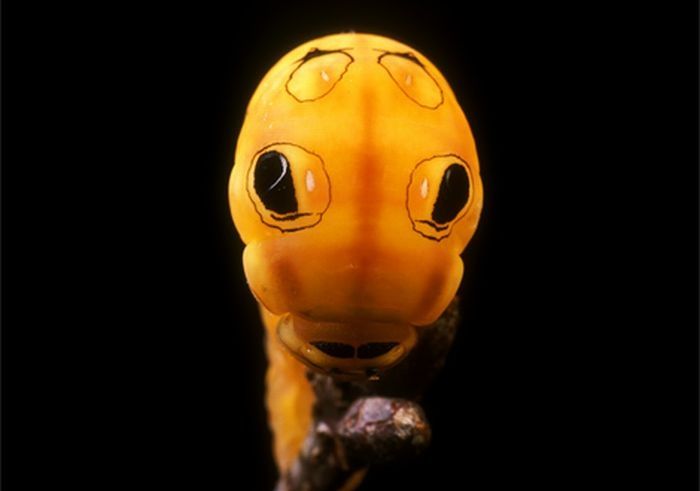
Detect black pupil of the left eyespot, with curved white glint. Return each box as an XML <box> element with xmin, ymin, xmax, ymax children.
<box><xmin>254</xmin><ymin>150</ymin><xmax>299</xmax><ymax>214</ymax></box>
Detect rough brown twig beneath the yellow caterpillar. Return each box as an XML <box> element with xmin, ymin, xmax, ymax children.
<box><xmin>275</xmin><ymin>299</ymin><xmax>459</xmax><ymax>491</ymax></box>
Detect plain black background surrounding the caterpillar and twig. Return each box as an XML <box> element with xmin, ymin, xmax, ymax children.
<box><xmin>2</xmin><ymin>1</ymin><xmax>698</xmax><ymax>490</ymax></box>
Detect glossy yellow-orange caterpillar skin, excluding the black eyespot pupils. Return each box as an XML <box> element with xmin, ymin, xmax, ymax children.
<box><xmin>229</xmin><ymin>33</ymin><xmax>483</xmax><ymax>469</ymax></box>
